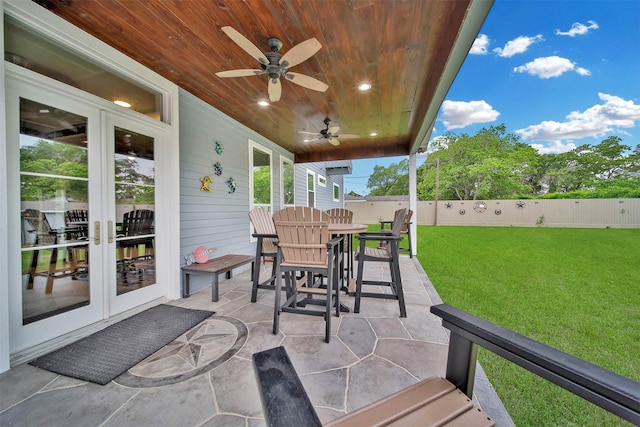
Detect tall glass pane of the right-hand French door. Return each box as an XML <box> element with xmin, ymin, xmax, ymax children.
<box><xmin>115</xmin><ymin>127</ymin><xmax>156</xmax><ymax>295</ymax></box>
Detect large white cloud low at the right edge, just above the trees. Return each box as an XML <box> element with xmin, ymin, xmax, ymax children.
<box><xmin>516</xmin><ymin>93</ymin><xmax>640</xmax><ymax>147</ymax></box>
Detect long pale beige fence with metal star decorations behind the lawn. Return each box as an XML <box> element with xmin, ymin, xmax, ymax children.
<box><xmin>345</xmin><ymin>198</ymin><xmax>640</xmax><ymax>228</ymax></box>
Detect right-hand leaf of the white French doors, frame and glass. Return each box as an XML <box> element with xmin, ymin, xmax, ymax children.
<box><xmin>104</xmin><ymin>114</ymin><xmax>162</xmax><ymax>316</ymax></box>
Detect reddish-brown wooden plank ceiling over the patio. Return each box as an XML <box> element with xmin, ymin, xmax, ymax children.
<box><xmin>37</xmin><ymin>0</ymin><xmax>471</xmax><ymax>162</ymax></box>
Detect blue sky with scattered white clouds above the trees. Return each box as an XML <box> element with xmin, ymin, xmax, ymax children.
<box><xmin>345</xmin><ymin>0</ymin><xmax>640</xmax><ymax>195</ymax></box>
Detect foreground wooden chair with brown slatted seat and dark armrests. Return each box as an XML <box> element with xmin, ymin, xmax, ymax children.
<box><xmin>253</xmin><ymin>304</ymin><xmax>640</xmax><ymax>427</ymax></box>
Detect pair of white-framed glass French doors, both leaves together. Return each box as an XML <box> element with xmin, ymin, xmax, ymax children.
<box><xmin>6</xmin><ymin>70</ymin><xmax>164</xmax><ymax>352</ymax></box>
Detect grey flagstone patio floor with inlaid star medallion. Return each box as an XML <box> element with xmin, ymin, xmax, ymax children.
<box><xmin>0</xmin><ymin>256</ymin><xmax>512</xmax><ymax>427</ymax></box>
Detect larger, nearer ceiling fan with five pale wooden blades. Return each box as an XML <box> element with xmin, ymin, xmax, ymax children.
<box><xmin>216</xmin><ymin>27</ymin><xmax>329</xmax><ymax>102</ymax></box>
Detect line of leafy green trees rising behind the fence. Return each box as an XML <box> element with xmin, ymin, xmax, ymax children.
<box><xmin>367</xmin><ymin>125</ymin><xmax>640</xmax><ymax>200</ymax></box>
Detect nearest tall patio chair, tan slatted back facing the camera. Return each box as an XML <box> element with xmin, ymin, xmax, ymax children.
<box><xmin>273</xmin><ymin>207</ymin><xmax>342</xmax><ymax>343</ymax></box>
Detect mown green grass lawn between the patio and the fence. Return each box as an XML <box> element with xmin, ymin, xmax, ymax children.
<box><xmin>418</xmin><ymin>226</ymin><xmax>640</xmax><ymax>427</ymax></box>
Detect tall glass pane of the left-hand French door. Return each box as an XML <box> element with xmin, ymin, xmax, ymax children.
<box><xmin>20</xmin><ymin>98</ymin><xmax>90</xmax><ymax>324</ymax></box>
